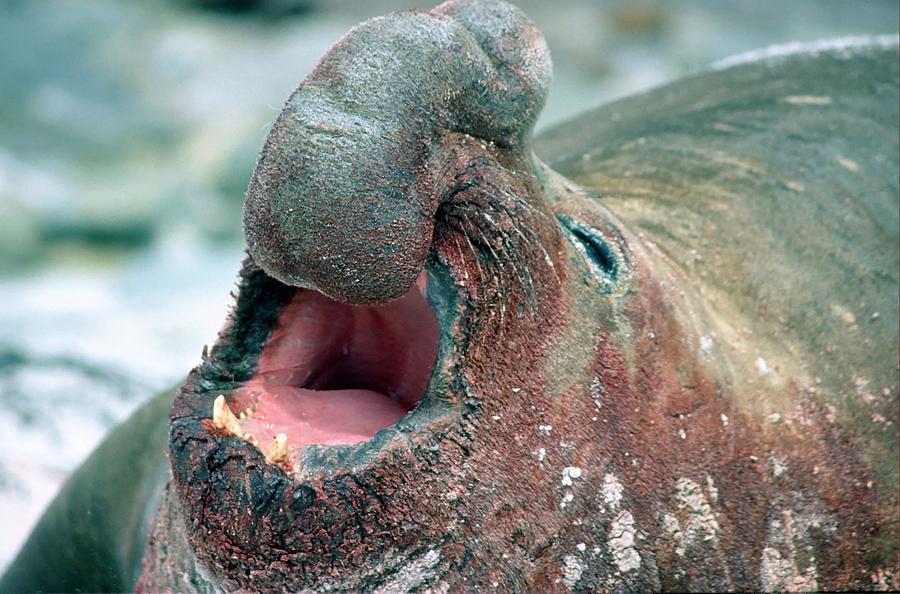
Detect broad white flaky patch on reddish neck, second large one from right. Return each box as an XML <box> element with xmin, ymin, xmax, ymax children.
<box><xmin>663</xmin><ymin>477</ymin><xmax>719</xmax><ymax>556</ymax></box>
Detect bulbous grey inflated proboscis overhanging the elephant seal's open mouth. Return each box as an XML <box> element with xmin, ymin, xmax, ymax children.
<box><xmin>244</xmin><ymin>1</ymin><xmax>551</xmax><ymax>303</ymax></box>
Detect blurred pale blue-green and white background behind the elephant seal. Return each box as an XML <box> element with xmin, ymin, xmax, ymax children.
<box><xmin>0</xmin><ymin>0</ymin><xmax>898</xmax><ymax>571</ymax></box>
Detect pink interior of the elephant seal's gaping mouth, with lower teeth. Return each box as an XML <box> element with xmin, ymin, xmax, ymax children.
<box><xmin>213</xmin><ymin>271</ymin><xmax>439</xmax><ymax>472</ymax></box>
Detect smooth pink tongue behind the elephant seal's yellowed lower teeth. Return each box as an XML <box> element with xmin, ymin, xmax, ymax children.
<box><xmin>241</xmin><ymin>380</ymin><xmax>407</xmax><ymax>454</ymax></box>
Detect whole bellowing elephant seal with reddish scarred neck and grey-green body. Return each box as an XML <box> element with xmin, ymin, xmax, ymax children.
<box><xmin>0</xmin><ymin>1</ymin><xmax>900</xmax><ymax>592</ymax></box>
